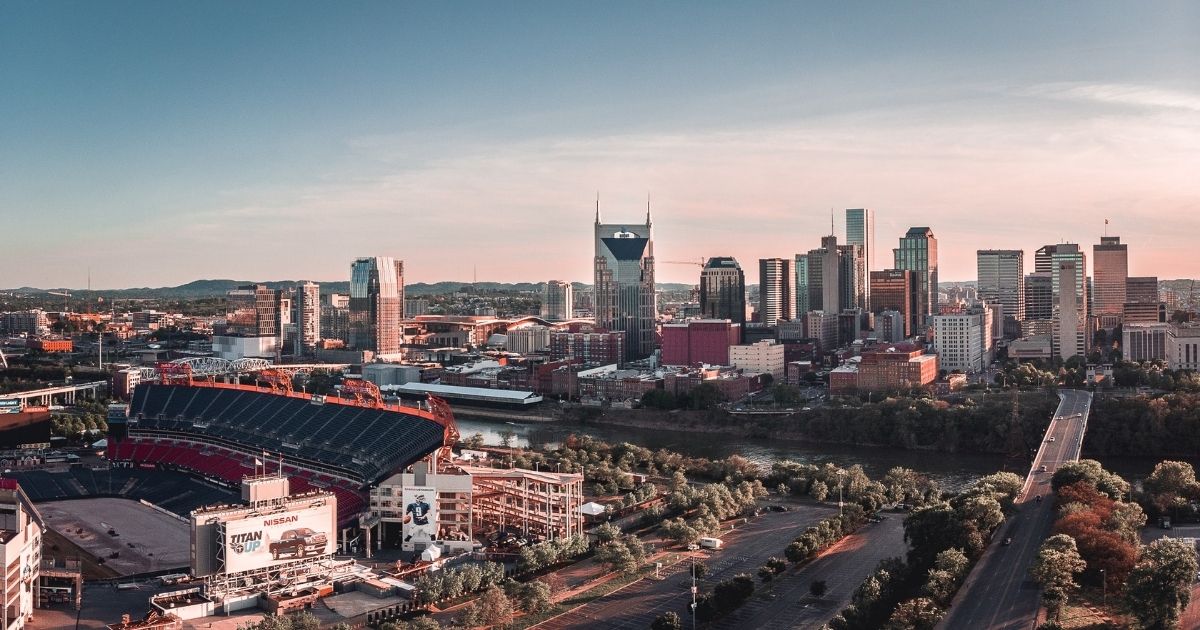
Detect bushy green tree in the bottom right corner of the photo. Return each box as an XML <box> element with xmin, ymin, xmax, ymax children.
<box><xmin>1126</xmin><ymin>539</ymin><xmax>1196</xmax><ymax>630</ymax></box>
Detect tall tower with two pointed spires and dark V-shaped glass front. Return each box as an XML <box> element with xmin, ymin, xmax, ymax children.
<box><xmin>594</xmin><ymin>202</ymin><xmax>658</xmax><ymax>360</ymax></box>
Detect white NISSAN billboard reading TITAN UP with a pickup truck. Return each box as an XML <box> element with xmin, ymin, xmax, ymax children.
<box><xmin>224</xmin><ymin>502</ymin><xmax>337</xmax><ymax>574</ymax></box>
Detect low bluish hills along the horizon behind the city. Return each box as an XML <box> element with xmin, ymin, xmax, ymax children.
<box><xmin>0</xmin><ymin>278</ymin><xmax>691</xmax><ymax>299</ymax></box>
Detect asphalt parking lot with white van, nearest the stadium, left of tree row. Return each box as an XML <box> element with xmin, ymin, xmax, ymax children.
<box><xmin>535</xmin><ymin>505</ymin><xmax>835</xmax><ymax>630</ymax></box>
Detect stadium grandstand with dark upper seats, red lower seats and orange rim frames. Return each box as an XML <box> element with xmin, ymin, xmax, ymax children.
<box><xmin>107</xmin><ymin>364</ymin><xmax>458</xmax><ymax>532</ymax></box>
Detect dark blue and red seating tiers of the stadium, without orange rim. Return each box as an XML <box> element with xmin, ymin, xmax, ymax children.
<box><xmin>111</xmin><ymin>383</ymin><xmax>443</xmax><ymax>523</ymax></box>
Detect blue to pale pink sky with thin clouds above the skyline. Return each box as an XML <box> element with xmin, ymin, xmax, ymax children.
<box><xmin>0</xmin><ymin>0</ymin><xmax>1200</xmax><ymax>288</ymax></box>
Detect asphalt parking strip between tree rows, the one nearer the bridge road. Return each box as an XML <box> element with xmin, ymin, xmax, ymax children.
<box><xmin>713</xmin><ymin>514</ymin><xmax>908</xmax><ymax>630</ymax></box>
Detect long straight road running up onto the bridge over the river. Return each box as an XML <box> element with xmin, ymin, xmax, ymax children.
<box><xmin>937</xmin><ymin>390</ymin><xmax>1092</xmax><ymax>630</ymax></box>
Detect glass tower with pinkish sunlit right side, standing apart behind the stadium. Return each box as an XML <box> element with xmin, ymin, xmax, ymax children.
<box><xmin>350</xmin><ymin>256</ymin><xmax>404</xmax><ymax>354</ymax></box>
